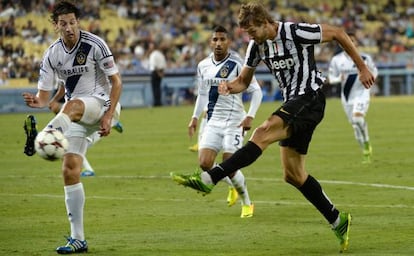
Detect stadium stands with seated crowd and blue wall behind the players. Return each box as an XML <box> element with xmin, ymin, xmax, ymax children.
<box><xmin>0</xmin><ymin>0</ymin><xmax>414</xmax><ymax>112</ymax></box>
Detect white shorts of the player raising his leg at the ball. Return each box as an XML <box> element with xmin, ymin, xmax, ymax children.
<box><xmin>65</xmin><ymin>97</ymin><xmax>121</xmax><ymax>156</ymax></box>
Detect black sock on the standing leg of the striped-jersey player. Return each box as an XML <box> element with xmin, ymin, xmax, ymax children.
<box><xmin>299</xmin><ymin>175</ymin><xmax>339</xmax><ymax>224</ymax></box>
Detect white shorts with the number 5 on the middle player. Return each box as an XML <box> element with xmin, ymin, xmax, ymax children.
<box><xmin>199</xmin><ymin>122</ymin><xmax>244</xmax><ymax>153</ymax></box>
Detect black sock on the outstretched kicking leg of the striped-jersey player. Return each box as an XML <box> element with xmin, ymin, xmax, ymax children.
<box><xmin>207</xmin><ymin>141</ymin><xmax>262</xmax><ymax>184</ymax></box>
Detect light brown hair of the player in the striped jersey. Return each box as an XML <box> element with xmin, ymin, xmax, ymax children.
<box><xmin>239</xmin><ymin>2</ymin><xmax>275</xmax><ymax>28</ymax></box>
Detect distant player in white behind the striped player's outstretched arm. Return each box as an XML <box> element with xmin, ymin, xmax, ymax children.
<box><xmin>328</xmin><ymin>32</ymin><xmax>378</xmax><ymax>163</ymax></box>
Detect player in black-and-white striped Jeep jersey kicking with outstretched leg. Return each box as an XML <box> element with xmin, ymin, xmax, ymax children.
<box><xmin>171</xmin><ymin>2</ymin><xmax>375</xmax><ymax>252</ymax></box>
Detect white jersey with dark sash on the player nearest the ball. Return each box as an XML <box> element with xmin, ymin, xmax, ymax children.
<box><xmin>38</xmin><ymin>30</ymin><xmax>118</xmax><ymax>104</ymax></box>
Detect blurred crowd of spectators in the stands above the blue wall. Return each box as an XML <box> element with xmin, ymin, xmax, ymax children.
<box><xmin>0</xmin><ymin>0</ymin><xmax>414</xmax><ymax>83</ymax></box>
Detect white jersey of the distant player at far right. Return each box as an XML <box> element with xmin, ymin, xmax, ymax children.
<box><xmin>329</xmin><ymin>51</ymin><xmax>378</xmax><ymax>104</ymax></box>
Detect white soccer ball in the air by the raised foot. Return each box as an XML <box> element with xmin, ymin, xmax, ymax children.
<box><xmin>35</xmin><ymin>129</ymin><xmax>69</xmax><ymax>161</ymax></box>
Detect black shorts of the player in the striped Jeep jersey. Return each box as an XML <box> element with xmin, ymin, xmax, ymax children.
<box><xmin>273</xmin><ymin>90</ymin><xmax>326</xmax><ymax>155</ymax></box>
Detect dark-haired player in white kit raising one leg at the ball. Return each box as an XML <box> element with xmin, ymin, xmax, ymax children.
<box><xmin>23</xmin><ymin>0</ymin><xmax>122</xmax><ymax>254</ymax></box>
